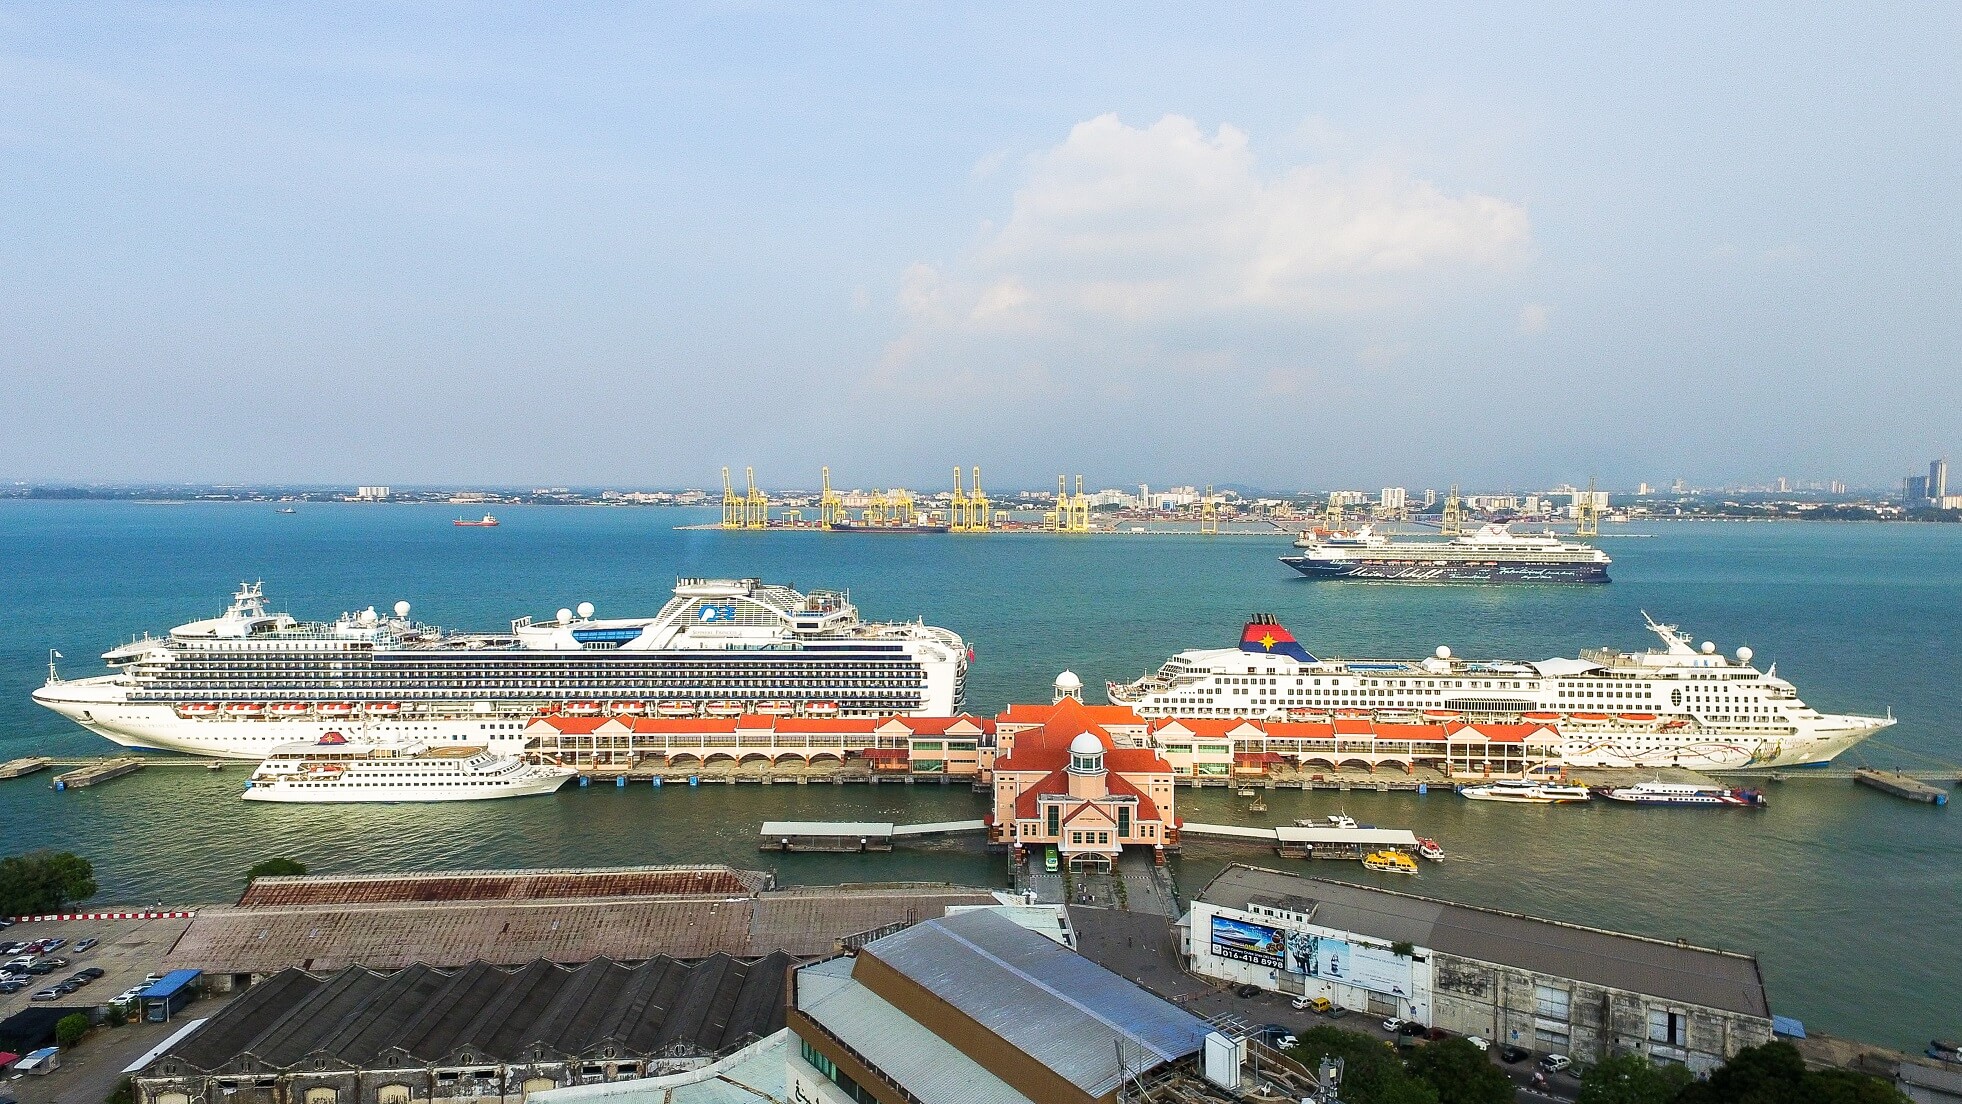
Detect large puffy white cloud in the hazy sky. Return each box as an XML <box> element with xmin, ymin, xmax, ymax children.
<box><xmin>901</xmin><ymin>116</ymin><xmax>1530</xmax><ymax>331</ymax></box>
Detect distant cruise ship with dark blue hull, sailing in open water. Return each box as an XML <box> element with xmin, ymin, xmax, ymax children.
<box><xmin>1281</xmin><ymin>526</ymin><xmax>1613</xmax><ymax>582</ymax></box>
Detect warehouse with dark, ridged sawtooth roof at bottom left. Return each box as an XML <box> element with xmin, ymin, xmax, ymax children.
<box><xmin>135</xmin><ymin>953</ymin><xmax>795</xmax><ymax>1104</ymax></box>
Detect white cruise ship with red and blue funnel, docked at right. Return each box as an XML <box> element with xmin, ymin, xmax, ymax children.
<box><xmin>1109</xmin><ymin>614</ymin><xmax>1893</xmax><ymax>771</ymax></box>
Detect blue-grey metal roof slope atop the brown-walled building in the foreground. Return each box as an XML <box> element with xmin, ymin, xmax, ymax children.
<box><xmin>865</xmin><ymin>910</ymin><xmax>1209</xmax><ymax>1096</ymax></box>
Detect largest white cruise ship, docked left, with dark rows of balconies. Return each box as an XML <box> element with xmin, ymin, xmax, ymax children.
<box><xmin>33</xmin><ymin>578</ymin><xmax>971</xmax><ymax>759</ymax></box>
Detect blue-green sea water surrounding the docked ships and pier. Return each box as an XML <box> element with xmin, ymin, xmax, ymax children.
<box><xmin>0</xmin><ymin>502</ymin><xmax>1962</xmax><ymax>1049</ymax></box>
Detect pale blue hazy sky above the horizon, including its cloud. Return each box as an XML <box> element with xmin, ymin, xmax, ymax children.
<box><xmin>0</xmin><ymin>4</ymin><xmax>1962</xmax><ymax>488</ymax></box>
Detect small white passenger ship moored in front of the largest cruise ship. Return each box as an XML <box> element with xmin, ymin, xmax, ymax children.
<box><xmin>245</xmin><ymin>733</ymin><xmax>577</xmax><ymax>804</ymax></box>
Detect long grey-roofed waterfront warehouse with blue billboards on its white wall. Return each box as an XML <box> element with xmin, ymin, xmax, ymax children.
<box><xmin>1179</xmin><ymin>865</ymin><xmax>1772</xmax><ymax>1071</ymax></box>
